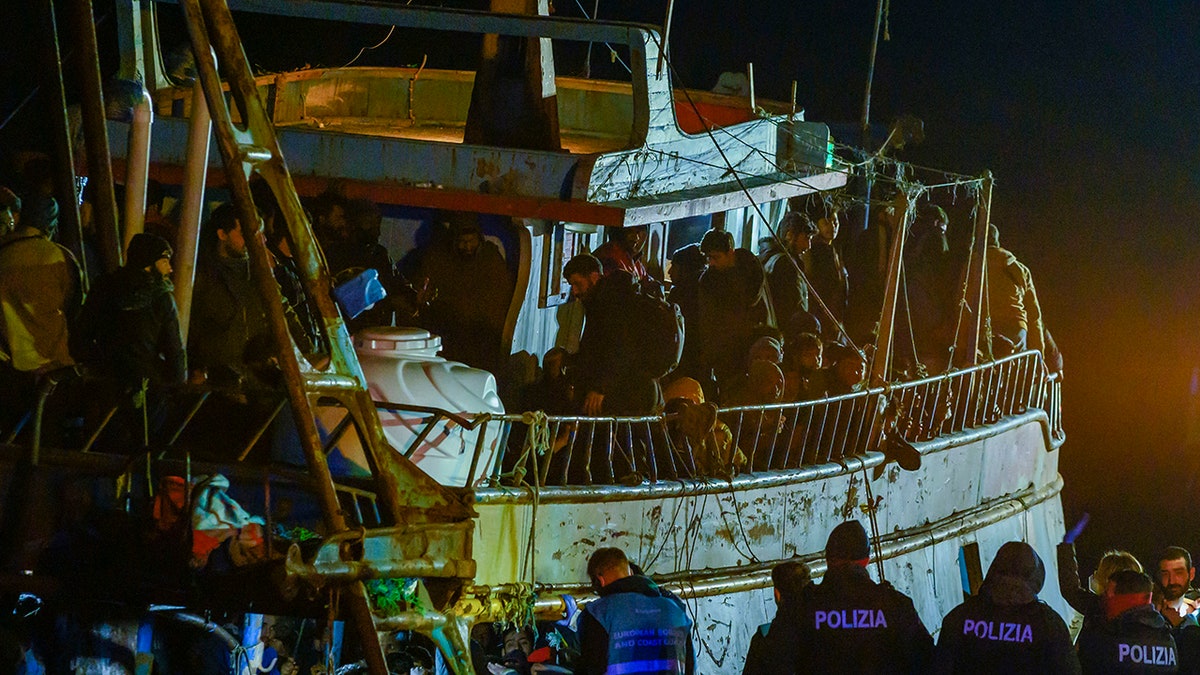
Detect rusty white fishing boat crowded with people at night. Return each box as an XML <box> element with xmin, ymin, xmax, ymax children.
<box><xmin>5</xmin><ymin>0</ymin><xmax>1069</xmax><ymax>662</ymax></box>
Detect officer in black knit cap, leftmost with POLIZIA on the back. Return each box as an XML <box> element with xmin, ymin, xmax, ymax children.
<box><xmin>772</xmin><ymin>520</ymin><xmax>934</xmax><ymax>674</ymax></box>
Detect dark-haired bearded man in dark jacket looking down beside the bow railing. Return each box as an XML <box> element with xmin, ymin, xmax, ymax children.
<box><xmin>563</xmin><ymin>253</ymin><xmax>662</xmax><ymax>416</ymax></box>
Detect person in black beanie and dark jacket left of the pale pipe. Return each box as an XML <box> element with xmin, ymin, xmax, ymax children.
<box><xmin>73</xmin><ymin>233</ymin><xmax>187</xmax><ymax>389</ymax></box>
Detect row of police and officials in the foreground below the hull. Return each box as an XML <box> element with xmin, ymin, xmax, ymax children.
<box><xmin>456</xmin><ymin>520</ymin><xmax>1200</xmax><ymax>675</ymax></box>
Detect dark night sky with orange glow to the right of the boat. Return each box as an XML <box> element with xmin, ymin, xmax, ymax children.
<box><xmin>0</xmin><ymin>0</ymin><xmax>1200</xmax><ymax>567</ymax></box>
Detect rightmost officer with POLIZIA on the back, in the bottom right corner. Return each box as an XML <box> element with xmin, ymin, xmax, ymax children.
<box><xmin>1078</xmin><ymin>569</ymin><xmax>1178</xmax><ymax>675</ymax></box>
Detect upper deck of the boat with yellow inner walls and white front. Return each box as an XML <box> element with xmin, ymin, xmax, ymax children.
<box><xmin>119</xmin><ymin>0</ymin><xmax>845</xmax><ymax>226</ymax></box>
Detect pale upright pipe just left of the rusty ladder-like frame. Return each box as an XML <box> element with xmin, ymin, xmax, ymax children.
<box><xmin>172</xmin><ymin>80</ymin><xmax>212</xmax><ymax>345</ymax></box>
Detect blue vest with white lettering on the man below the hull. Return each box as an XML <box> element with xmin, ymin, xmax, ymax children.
<box><xmin>587</xmin><ymin>592</ymin><xmax>691</xmax><ymax>675</ymax></box>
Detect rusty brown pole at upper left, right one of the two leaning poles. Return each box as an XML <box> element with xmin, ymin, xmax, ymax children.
<box><xmin>70</xmin><ymin>0</ymin><xmax>122</xmax><ymax>271</ymax></box>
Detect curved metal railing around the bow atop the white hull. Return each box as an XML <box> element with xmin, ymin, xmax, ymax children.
<box><xmin>439</xmin><ymin>351</ymin><xmax>1062</xmax><ymax>486</ymax></box>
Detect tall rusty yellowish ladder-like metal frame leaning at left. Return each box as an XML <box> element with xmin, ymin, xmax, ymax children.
<box><xmin>179</xmin><ymin>0</ymin><xmax>475</xmax><ymax>675</ymax></box>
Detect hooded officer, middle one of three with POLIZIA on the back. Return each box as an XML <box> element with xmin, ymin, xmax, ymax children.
<box><xmin>935</xmin><ymin>542</ymin><xmax>1079</xmax><ymax>675</ymax></box>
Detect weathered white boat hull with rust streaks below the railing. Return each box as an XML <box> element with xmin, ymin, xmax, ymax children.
<box><xmin>474</xmin><ymin>411</ymin><xmax>1070</xmax><ymax>673</ymax></box>
